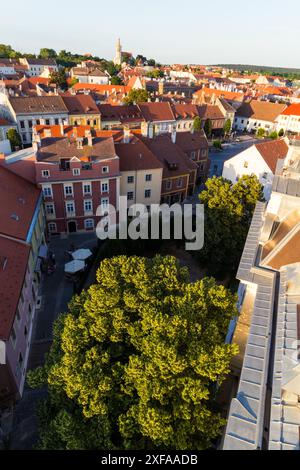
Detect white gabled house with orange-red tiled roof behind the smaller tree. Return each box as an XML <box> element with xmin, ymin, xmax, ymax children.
<box><xmin>222</xmin><ymin>139</ymin><xmax>289</xmax><ymax>200</ymax></box>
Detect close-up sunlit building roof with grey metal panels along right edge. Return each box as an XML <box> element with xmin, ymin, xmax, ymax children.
<box><xmin>223</xmin><ymin>140</ymin><xmax>300</xmax><ymax>450</ymax></box>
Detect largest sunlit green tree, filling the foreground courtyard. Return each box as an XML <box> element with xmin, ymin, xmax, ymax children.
<box><xmin>28</xmin><ymin>256</ymin><xmax>237</xmax><ymax>450</ymax></box>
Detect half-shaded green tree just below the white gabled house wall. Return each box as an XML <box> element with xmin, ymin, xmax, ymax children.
<box><xmin>199</xmin><ymin>175</ymin><xmax>263</xmax><ymax>277</ymax></box>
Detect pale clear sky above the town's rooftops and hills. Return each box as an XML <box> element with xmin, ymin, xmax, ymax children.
<box><xmin>0</xmin><ymin>0</ymin><xmax>300</xmax><ymax>68</ymax></box>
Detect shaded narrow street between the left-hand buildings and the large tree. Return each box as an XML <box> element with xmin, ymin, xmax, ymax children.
<box><xmin>9</xmin><ymin>233</ymin><xmax>97</xmax><ymax>450</ymax></box>
